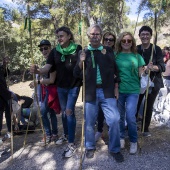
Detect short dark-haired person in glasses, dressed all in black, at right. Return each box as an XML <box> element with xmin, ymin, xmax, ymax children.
<box><xmin>136</xmin><ymin>26</ymin><xmax>165</xmax><ymax>136</ymax></box>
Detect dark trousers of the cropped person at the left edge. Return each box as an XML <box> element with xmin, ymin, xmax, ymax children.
<box><xmin>0</xmin><ymin>103</ymin><xmax>11</xmax><ymax>132</ymax></box>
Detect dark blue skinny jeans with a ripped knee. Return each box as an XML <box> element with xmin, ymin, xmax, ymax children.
<box><xmin>57</xmin><ymin>87</ymin><xmax>80</xmax><ymax>143</ymax></box>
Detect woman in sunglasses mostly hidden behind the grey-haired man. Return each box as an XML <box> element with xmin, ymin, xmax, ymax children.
<box><xmin>95</xmin><ymin>32</ymin><xmax>118</xmax><ymax>142</ymax></box>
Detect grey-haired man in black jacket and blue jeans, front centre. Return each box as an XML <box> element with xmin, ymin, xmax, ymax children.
<box><xmin>74</xmin><ymin>24</ymin><xmax>124</xmax><ymax>162</ymax></box>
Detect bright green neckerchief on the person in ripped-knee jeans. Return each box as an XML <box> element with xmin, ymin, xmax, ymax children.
<box><xmin>56</xmin><ymin>42</ymin><xmax>78</xmax><ymax>62</ymax></box>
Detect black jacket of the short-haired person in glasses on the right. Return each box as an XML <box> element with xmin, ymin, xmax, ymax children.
<box><xmin>137</xmin><ymin>44</ymin><xmax>165</xmax><ymax>91</ymax></box>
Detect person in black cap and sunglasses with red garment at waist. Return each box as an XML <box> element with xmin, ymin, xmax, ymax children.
<box><xmin>30</xmin><ymin>40</ymin><xmax>60</xmax><ymax>144</ymax></box>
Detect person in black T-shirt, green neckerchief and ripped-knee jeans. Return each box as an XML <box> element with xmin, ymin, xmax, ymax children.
<box><xmin>30</xmin><ymin>26</ymin><xmax>82</xmax><ymax>158</ymax></box>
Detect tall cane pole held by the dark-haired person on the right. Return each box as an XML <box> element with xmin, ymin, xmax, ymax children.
<box><xmin>139</xmin><ymin>0</ymin><xmax>163</xmax><ymax>153</ymax></box>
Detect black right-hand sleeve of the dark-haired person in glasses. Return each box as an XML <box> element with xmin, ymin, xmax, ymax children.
<box><xmin>153</xmin><ymin>46</ymin><xmax>165</xmax><ymax>72</ymax></box>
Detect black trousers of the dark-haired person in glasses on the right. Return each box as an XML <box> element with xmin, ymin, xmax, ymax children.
<box><xmin>136</xmin><ymin>89</ymin><xmax>159</xmax><ymax>132</ymax></box>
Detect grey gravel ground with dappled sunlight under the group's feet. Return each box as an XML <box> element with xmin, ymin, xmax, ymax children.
<box><xmin>0</xmin><ymin>81</ymin><xmax>170</xmax><ymax>170</ymax></box>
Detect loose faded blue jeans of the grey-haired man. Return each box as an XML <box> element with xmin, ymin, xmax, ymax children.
<box><xmin>85</xmin><ymin>88</ymin><xmax>120</xmax><ymax>153</ymax></box>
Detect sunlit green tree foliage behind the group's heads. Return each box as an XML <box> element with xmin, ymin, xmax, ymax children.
<box><xmin>0</xmin><ymin>0</ymin><xmax>170</xmax><ymax>74</ymax></box>
